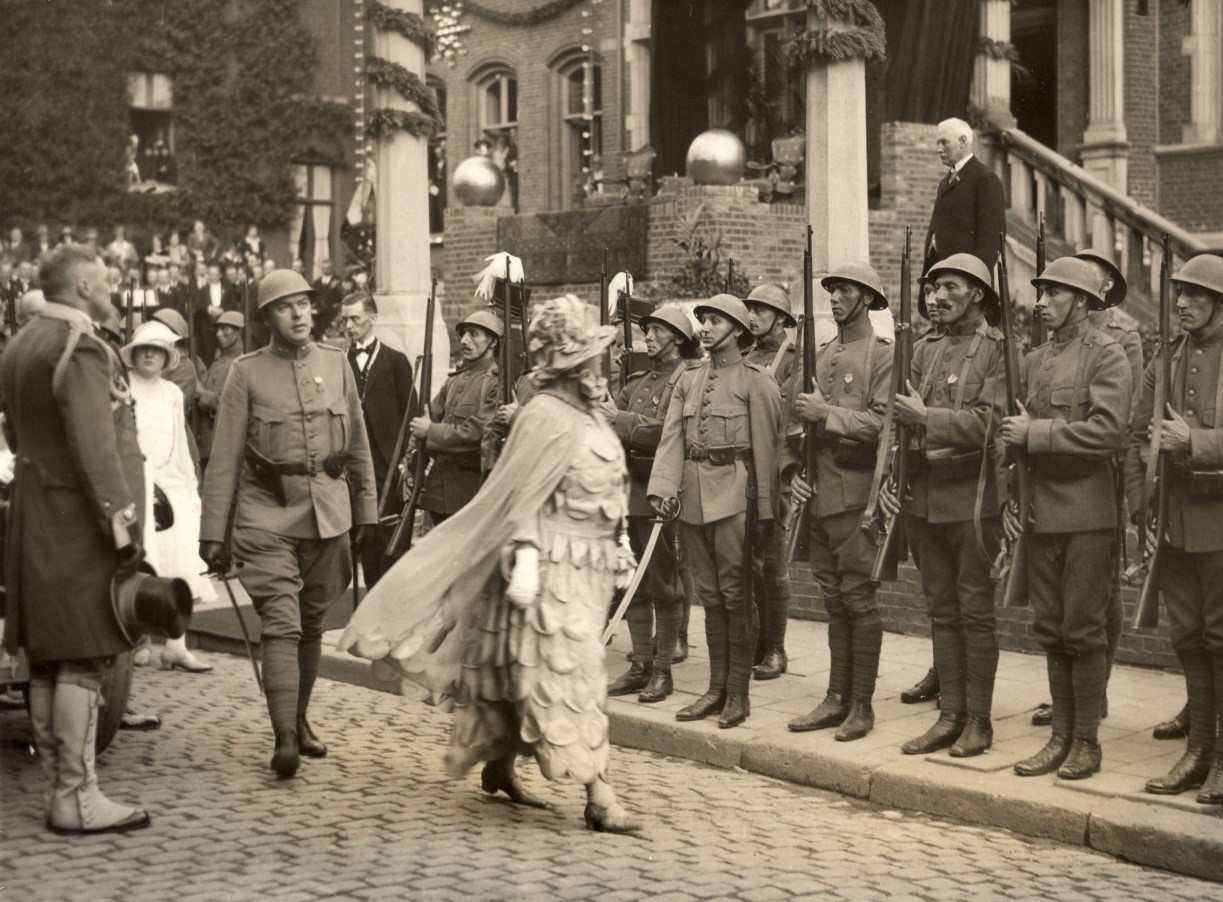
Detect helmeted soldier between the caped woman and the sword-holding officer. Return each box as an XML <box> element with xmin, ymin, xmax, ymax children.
<box><xmin>608</xmin><ymin>301</ymin><xmax>698</xmax><ymax>703</ymax></box>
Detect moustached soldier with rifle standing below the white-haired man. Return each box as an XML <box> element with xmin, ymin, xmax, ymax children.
<box><xmin>881</xmin><ymin>254</ymin><xmax>1007</xmax><ymax>758</ymax></box>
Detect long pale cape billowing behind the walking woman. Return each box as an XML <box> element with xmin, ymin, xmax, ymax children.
<box><xmin>339</xmin><ymin>391</ymin><xmax>583</xmax><ymax>695</ymax></box>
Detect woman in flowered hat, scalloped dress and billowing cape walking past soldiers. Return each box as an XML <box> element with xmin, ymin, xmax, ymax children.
<box><xmin>339</xmin><ymin>296</ymin><xmax>640</xmax><ymax>832</ymax></box>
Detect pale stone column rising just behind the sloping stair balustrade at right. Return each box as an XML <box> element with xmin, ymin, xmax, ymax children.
<box><xmin>1080</xmin><ymin>0</ymin><xmax>1129</xmax><ymax>193</ymax></box>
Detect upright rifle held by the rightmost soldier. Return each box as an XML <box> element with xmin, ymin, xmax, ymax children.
<box><xmin>1126</xmin><ymin>232</ymin><xmax>1173</xmax><ymax>629</ymax></box>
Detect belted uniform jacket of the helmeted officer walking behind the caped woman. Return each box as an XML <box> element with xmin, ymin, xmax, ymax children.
<box><xmin>199</xmin><ymin>339</ymin><xmax>378</xmax><ymax>541</ymax></box>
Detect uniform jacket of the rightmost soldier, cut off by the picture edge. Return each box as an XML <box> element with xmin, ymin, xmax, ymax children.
<box><xmin>1125</xmin><ymin>323</ymin><xmax>1223</xmax><ymax>552</ymax></box>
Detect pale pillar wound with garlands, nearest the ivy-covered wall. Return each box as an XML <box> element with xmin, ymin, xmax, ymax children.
<box><xmin>374</xmin><ymin>0</ymin><xmax>450</xmax><ymax>386</ymax></box>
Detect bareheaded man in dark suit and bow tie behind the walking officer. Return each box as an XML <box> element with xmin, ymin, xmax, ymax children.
<box><xmin>340</xmin><ymin>292</ymin><xmax>412</xmax><ymax>589</ymax></box>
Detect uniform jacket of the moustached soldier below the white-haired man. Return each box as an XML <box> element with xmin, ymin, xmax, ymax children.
<box><xmin>905</xmin><ymin>315</ymin><xmax>1007</xmax><ymax>523</ymax></box>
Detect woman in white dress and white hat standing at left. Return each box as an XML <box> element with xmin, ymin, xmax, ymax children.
<box><xmin>121</xmin><ymin>320</ymin><xmax>216</xmax><ymax>673</ymax></box>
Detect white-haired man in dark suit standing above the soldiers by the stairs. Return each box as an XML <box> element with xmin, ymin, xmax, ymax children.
<box><xmin>922</xmin><ymin>119</ymin><xmax>1007</xmax><ymax>271</ymax></box>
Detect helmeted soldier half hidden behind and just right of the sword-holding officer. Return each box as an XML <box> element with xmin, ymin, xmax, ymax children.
<box><xmin>744</xmin><ymin>284</ymin><xmax>799</xmax><ymax>680</ymax></box>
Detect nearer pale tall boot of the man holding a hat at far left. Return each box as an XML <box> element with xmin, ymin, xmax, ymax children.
<box><xmin>48</xmin><ymin>682</ymin><xmax>150</xmax><ymax>835</ymax></box>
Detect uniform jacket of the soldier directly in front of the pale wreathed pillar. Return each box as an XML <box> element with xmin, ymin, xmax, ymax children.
<box><xmin>778</xmin><ymin>313</ymin><xmax>895</xmax><ymax>517</ymax></box>
